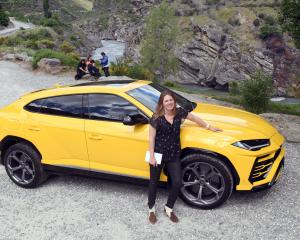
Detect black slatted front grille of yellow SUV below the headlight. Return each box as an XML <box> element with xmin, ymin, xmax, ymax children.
<box><xmin>249</xmin><ymin>147</ymin><xmax>281</xmax><ymax>183</ymax></box>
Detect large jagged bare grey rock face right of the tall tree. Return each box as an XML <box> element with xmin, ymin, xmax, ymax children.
<box><xmin>178</xmin><ymin>25</ymin><xmax>274</xmax><ymax>89</ymax></box>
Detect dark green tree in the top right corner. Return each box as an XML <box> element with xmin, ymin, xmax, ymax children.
<box><xmin>279</xmin><ymin>0</ymin><xmax>300</xmax><ymax>49</ymax></box>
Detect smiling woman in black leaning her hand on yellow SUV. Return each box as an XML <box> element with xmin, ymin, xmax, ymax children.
<box><xmin>148</xmin><ymin>90</ymin><xmax>222</xmax><ymax>224</ymax></box>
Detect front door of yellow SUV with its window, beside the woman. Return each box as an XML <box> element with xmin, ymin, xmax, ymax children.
<box><xmin>85</xmin><ymin>94</ymin><xmax>149</xmax><ymax>178</ymax></box>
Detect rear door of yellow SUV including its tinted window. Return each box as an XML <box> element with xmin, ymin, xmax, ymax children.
<box><xmin>24</xmin><ymin>94</ymin><xmax>89</xmax><ymax>169</ymax></box>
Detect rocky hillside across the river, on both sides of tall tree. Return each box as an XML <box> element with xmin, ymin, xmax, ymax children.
<box><xmin>80</xmin><ymin>0</ymin><xmax>300</xmax><ymax>97</ymax></box>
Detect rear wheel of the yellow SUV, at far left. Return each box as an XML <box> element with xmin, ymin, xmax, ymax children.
<box><xmin>4</xmin><ymin>143</ymin><xmax>48</xmax><ymax>188</ymax></box>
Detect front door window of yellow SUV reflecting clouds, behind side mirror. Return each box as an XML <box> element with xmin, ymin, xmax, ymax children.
<box><xmin>89</xmin><ymin>94</ymin><xmax>139</xmax><ymax>121</ymax></box>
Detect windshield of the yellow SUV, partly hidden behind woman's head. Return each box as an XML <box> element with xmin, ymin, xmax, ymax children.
<box><xmin>127</xmin><ymin>83</ymin><xmax>197</xmax><ymax>112</ymax></box>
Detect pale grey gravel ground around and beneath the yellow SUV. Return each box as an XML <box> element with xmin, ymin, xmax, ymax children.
<box><xmin>0</xmin><ymin>61</ymin><xmax>300</xmax><ymax>240</ymax></box>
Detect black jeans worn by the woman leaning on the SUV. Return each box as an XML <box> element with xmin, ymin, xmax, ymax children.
<box><xmin>148</xmin><ymin>161</ymin><xmax>182</xmax><ymax>209</ymax></box>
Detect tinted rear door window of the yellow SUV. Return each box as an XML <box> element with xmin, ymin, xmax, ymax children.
<box><xmin>40</xmin><ymin>95</ymin><xmax>83</xmax><ymax>117</ymax></box>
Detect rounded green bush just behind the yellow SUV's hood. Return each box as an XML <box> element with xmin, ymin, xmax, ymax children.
<box><xmin>240</xmin><ymin>71</ymin><xmax>274</xmax><ymax>113</ymax></box>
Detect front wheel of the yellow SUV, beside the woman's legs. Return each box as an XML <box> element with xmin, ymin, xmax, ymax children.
<box><xmin>180</xmin><ymin>154</ymin><xmax>233</xmax><ymax>209</ymax></box>
